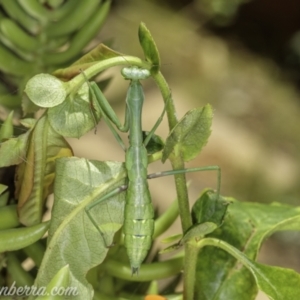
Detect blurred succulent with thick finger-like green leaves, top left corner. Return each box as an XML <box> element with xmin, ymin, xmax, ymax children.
<box><xmin>0</xmin><ymin>0</ymin><xmax>110</xmax><ymax>113</ymax></box>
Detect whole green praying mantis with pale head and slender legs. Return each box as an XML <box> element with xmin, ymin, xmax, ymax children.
<box><xmin>82</xmin><ymin>67</ymin><xmax>220</xmax><ymax>274</ymax></box>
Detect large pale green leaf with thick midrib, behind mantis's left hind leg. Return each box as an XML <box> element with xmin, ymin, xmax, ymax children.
<box><xmin>36</xmin><ymin>157</ymin><xmax>126</xmax><ymax>300</ymax></box>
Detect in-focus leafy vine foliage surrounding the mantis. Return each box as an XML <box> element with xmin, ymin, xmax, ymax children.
<box><xmin>0</xmin><ymin>18</ymin><xmax>300</xmax><ymax>300</ymax></box>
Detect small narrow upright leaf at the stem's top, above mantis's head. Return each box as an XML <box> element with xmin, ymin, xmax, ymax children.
<box><xmin>139</xmin><ymin>23</ymin><xmax>160</xmax><ymax>73</ymax></box>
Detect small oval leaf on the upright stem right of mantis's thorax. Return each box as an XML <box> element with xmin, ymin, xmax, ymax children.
<box><xmin>162</xmin><ymin>104</ymin><xmax>213</xmax><ymax>162</ymax></box>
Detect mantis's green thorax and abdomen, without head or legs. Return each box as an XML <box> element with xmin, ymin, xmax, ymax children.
<box><xmin>123</xmin><ymin>81</ymin><xmax>154</xmax><ymax>273</ymax></box>
